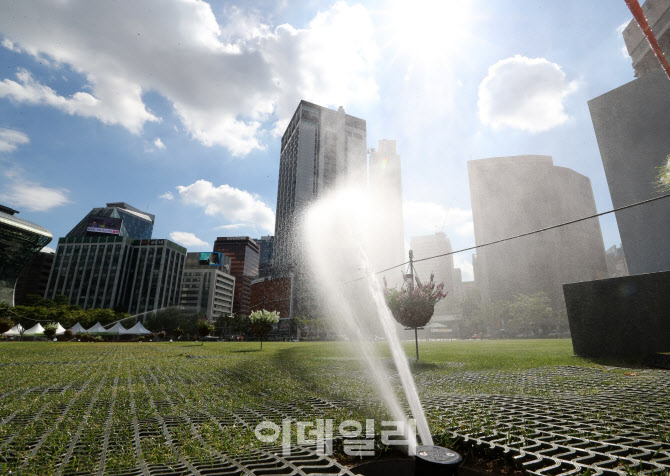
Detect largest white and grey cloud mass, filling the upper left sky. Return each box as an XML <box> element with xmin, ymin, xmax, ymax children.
<box><xmin>0</xmin><ymin>0</ymin><xmax>378</xmax><ymax>156</ymax></box>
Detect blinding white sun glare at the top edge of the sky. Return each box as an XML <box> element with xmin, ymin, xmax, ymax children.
<box><xmin>380</xmin><ymin>0</ymin><xmax>472</xmax><ymax>65</ymax></box>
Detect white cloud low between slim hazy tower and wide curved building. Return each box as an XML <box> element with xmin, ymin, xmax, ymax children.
<box><xmin>403</xmin><ymin>200</ymin><xmax>474</xmax><ymax>240</ymax></box>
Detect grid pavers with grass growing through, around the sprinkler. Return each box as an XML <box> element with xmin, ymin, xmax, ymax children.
<box><xmin>0</xmin><ymin>343</ymin><xmax>670</xmax><ymax>476</ymax></box>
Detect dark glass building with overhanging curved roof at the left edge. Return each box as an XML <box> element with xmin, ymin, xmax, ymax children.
<box><xmin>0</xmin><ymin>205</ymin><xmax>53</xmax><ymax>306</ymax></box>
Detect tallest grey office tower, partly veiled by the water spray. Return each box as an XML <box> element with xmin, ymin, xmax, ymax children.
<box><xmin>274</xmin><ymin>101</ymin><xmax>367</xmax><ymax>270</ymax></box>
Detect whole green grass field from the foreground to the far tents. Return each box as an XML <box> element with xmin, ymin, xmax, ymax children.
<box><xmin>0</xmin><ymin>339</ymin><xmax>670</xmax><ymax>474</ymax></box>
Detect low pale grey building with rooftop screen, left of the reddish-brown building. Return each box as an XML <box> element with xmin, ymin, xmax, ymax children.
<box><xmin>180</xmin><ymin>253</ymin><xmax>235</xmax><ymax>319</ymax></box>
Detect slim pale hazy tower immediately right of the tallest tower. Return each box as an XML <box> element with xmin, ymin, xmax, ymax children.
<box><xmin>370</xmin><ymin>139</ymin><xmax>407</xmax><ymax>285</ymax></box>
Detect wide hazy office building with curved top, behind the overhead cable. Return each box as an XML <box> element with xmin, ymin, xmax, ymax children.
<box><xmin>468</xmin><ymin>155</ymin><xmax>607</xmax><ymax>309</ymax></box>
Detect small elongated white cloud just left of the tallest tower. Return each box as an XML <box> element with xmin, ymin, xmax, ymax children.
<box><xmin>177</xmin><ymin>180</ymin><xmax>275</xmax><ymax>232</ymax></box>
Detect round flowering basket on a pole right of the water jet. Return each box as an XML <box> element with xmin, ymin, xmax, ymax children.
<box><xmin>384</xmin><ymin>274</ymin><xmax>447</xmax><ymax>360</ymax></box>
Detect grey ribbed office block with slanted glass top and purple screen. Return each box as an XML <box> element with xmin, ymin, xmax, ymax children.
<box><xmin>44</xmin><ymin>202</ymin><xmax>186</xmax><ymax>314</ymax></box>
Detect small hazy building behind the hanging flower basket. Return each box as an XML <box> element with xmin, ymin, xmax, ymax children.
<box><xmin>410</xmin><ymin>232</ymin><xmax>455</xmax><ymax>314</ymax></box>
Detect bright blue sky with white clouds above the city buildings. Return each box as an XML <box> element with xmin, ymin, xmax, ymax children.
<box><xmin>0</xmin><ymin>0</ymin><xmax>634</xmax><ymax>280</ymax></box>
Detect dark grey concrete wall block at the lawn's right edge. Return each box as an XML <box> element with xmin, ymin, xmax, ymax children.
<box><xmin>563</xmin><ymin>272</ymin><xmax>670</xmax><ymax>357</ymax></box>
